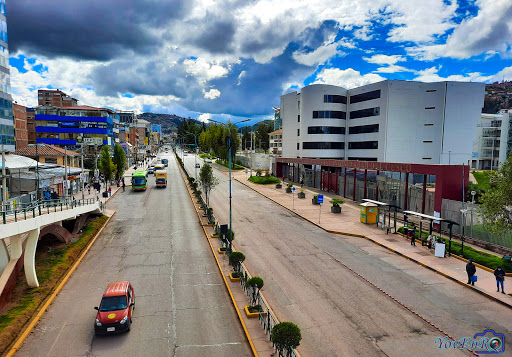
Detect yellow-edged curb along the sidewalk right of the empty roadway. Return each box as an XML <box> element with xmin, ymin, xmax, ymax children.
<box><xmin>235</xmin><ymin>178</ymin><xmax>512</xmax><ymax>309</ymax></box>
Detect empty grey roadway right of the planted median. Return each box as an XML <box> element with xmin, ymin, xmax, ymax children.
<box><xmin>185</xmin><ymin>154</ymin><xmax>512</xmax><ymax>357</ymax></box>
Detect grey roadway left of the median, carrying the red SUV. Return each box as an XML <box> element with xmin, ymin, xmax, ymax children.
<box><xmin>17</xmin><ymin>154</ymin><xmax>252</xmax><ymax>357</ymax></box>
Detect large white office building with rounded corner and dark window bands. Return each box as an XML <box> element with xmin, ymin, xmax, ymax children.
<box><xmin>281</xmin><ymin>80</ymin><xmax>485</xmax><ymax>164</ymax></box>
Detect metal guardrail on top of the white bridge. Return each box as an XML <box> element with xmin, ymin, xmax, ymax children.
<box><xmin>0</xmin><ymin>198</ymin><xmax>103</xmax><ymax>224</ymax></box>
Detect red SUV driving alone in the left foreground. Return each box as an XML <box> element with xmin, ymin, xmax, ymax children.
<box><xmin>94</xmin><ymin>281</ymin><xmax>135</xmax><ymax>335</ymax></box>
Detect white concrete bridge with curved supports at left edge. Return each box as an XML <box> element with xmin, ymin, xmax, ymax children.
<box><xmin>0</xmin><ymin>199</ymin><xmax>103</xmax><ymax>308</ymax></box>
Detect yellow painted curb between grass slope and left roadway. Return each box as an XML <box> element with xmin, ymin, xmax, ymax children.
<box><xmin>5</xmin><ymin>211</ymin><xmax>116</xmax><ymax>357</ymax></box>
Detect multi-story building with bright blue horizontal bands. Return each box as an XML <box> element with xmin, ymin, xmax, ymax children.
<box><xmin>35</xmin><ymin>106</ymin><xmax>114</xmax><ymax>146</ymax></box>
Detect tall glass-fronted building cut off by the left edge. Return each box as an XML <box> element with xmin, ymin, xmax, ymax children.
<box><xmin>0</xmin><ymin>0</ymin><xmax>15</xmax><ymax>151</ymax></box>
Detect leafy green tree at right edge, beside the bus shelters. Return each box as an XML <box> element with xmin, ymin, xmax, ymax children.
<box><xmin>481</xmin><ymin>153</ymin><xmax>512</xmax><ymax>234</ymax></box>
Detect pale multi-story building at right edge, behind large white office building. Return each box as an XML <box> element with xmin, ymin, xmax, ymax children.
<box><xmin>471</xmin><ymin>109</ymin><xmax>512</xmax><ymax>170</ymax></box>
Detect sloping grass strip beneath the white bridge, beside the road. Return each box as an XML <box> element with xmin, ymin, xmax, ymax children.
<box><xmin>0</xmin><ymin>216</ymin><xmax>108</xmax><ymax>354</ymax></box>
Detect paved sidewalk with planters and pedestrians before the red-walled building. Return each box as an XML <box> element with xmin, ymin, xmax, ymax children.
<box><xmin>233</xmin><ymin>171</ymin><xmax>512</xmax><ymax>308</ymax></box>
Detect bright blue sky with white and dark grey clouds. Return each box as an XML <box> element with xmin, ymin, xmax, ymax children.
<box><xmin>6</xmin><ymin>0</ymin><xmax>512</xmax><ymax>121</ymax></box>
